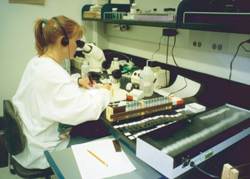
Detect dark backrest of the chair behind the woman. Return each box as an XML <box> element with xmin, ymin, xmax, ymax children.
<box><xmin>3</xmin><ymin>100</ymin><xmax>26</xmax><ymax>155</ymax></box>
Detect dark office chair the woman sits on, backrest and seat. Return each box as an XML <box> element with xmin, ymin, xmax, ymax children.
<box><xmin>3</xmin><ymin>100</ymin><xmax>53</xmax><ymax>178</ymax></box>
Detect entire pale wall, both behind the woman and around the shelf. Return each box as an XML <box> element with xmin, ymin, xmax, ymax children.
<box><xmin>0</xmin><ymin>0</ymin><xmax>250</xmax><ymax>116</ymax></box>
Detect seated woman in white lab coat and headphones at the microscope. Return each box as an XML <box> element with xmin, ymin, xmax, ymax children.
<box><xmin>12</xmin><ymin>16</ymin><xmax>110</xmax><ymax>169</ymax></box>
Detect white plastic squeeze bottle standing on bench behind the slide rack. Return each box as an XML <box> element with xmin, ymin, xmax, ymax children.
<box><xmin>139</xmin><ymin>66</ymin><xmax>154</xmax><ymax>97</ymax></box>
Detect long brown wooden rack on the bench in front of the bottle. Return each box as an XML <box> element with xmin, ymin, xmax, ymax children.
<box><xmin>106</xmin><ymin>98</ymin><xmax>172</xmax><ymax>122</ymax></box>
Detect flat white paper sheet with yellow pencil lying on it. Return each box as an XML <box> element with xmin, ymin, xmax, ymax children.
<box><xmin>72</xmin><ymin>139</ymin><xmax>136</xmax><ymax>179</ymax></box>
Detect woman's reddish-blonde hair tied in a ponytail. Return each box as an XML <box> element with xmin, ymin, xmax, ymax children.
<box><xmin>34</xmin><ymin>16</ymin><xmax>85</xmax><ymax>56</ymax></box>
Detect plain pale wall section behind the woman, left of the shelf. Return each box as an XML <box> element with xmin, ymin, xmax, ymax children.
<box><xmin>0</xmin><ymin>0</ymin><xmax>97</xmax><ymax>116</ymax></box>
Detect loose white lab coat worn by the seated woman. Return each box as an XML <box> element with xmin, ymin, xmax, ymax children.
<box><xmin>12</xmin><ymin>57</ymin><xmax>110</xmax><ymax>169</ymax></box>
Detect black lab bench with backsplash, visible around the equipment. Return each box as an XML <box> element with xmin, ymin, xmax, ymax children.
<box><xmin>68</xmin><ymin>50</ymin><xmax>250</xmax><ymax>179</ymax></box>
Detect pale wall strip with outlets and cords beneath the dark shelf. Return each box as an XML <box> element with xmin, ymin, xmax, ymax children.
<box><xmin>106</xmin><ymin>24</ymin><xmax>250</xmax><ymax>84</ymax></box>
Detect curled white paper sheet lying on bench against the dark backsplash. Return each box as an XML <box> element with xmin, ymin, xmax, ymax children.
<box><xmin>155</xmin><ymin>75</ymin><xmax>201</xmax><ymax>98</ymax></box>
